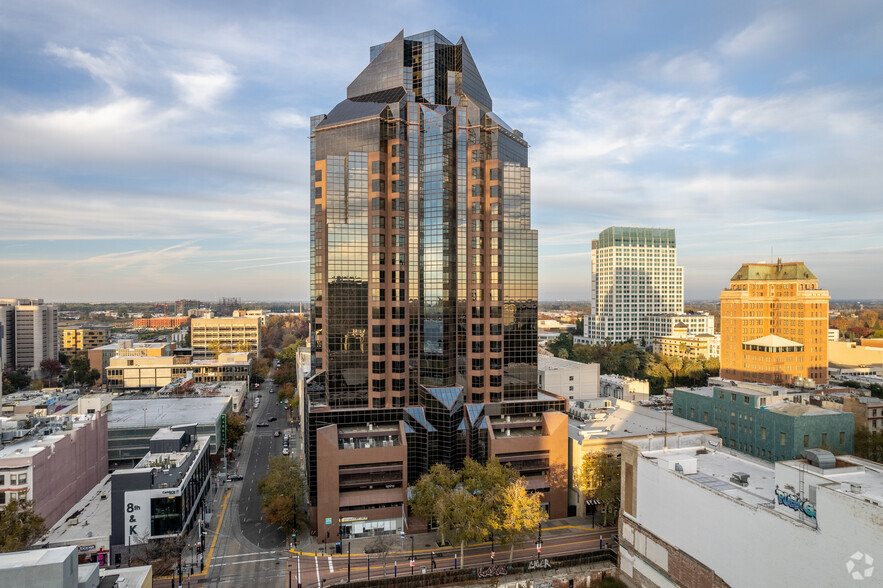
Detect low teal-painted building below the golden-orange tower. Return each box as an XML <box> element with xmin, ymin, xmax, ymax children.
<box><xmin>673</xmin><ymin>386</ymin><xmax>855</xmax><ymax>461</ymax></box>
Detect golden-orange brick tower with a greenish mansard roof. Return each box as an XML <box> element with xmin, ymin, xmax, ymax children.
<box><xmin>721</xmin><ymin>258</ymin><xmax>831</xmax><ymax>385</ymax></box>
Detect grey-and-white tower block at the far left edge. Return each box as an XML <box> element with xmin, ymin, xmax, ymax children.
<box><xmin>0</xmin><ymin>298</ymin><xmax>58</xmax><ymax>371</ymax></box>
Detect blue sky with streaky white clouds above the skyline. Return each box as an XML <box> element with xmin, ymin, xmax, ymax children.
<box><xmin>0</xmin><ymin>0</ymin><xmax>883</xmax><ymax>301</ymax></box>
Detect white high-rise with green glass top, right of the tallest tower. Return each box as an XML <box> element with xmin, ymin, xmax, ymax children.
<box><xmin>577</xmin><ymin>227</ymin><xmax>688</xmax><ymax>346</ymax></box>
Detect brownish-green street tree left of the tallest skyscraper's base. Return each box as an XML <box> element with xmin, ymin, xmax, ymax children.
<box><xmin>258</xmin><ymin>455</ymin><xmax>308</xmax><ymax>544</ymax></box>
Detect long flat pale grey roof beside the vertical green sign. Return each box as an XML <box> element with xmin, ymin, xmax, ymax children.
<box><xmin>107</xmin><ymin>396</ymin><xmax>229</xmax><ymax>429</ymax></box>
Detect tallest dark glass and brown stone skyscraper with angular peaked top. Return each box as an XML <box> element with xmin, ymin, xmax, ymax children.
<box><xmin>305</xmin><ymin>31</ymin><xmax>566</xmax><ymax>538</ymax></box>
